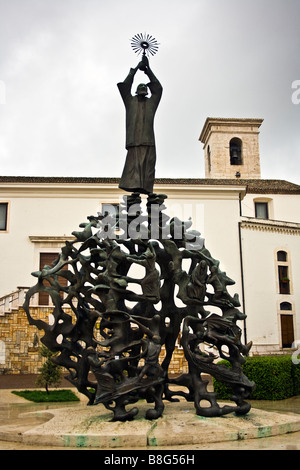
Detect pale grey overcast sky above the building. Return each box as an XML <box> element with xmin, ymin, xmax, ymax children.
<box><xmin>0</xmin><ymin>0</ymin><xmax>300</xmax><ymax>184</ymax></box>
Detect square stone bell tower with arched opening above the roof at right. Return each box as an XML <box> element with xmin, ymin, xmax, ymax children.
<box><xmin>199</xmin><ymin>118</ymin><xmax>263</xmax><ymax>179</ymax></box>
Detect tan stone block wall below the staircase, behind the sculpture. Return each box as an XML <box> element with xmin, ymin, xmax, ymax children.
<box><xmin>0</xmin><ymin>307</ymin><xmax>187</xmax><ymax>374</ymax></box>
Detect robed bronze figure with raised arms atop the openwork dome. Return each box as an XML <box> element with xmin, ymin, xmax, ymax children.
<box><xmin>117</xmin><ymin>55</ymin><xmax>162</xmax><ymax>194</ymax></box>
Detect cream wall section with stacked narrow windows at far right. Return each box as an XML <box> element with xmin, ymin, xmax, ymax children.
<box><xmin>241</xmin><ymin>217</ymin><xmax>300</xmax><ymax>353</ymax></box>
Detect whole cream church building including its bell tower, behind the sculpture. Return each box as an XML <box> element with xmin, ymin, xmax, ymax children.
<box><xmin>0</xmin><ymin>118</ymin><xmax>300</xmax><ymax>370</ymax></box>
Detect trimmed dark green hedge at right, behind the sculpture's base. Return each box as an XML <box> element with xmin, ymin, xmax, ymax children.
<box><xmin>213</xmin><ymin>355</ymin><xmax>300</xmax><ymax>400</ymax></box>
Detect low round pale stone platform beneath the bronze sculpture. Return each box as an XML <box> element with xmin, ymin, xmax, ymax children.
<box><xmin>0</xmin><ymin>402</ymin><xmax>300</xmax><ymax>449</ymax></box>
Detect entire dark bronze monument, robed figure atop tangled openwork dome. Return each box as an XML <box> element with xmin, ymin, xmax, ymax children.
<box><xmin>24</xmin><ymin>35</ymin><xmax>255</xmax><ymax>421</ymax></box>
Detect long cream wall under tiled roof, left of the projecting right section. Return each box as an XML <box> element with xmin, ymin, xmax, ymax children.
<box><xmin>0</xmin><ymin>178</ymin><xmax>246</xmax><ymax>296</ymax></box>
